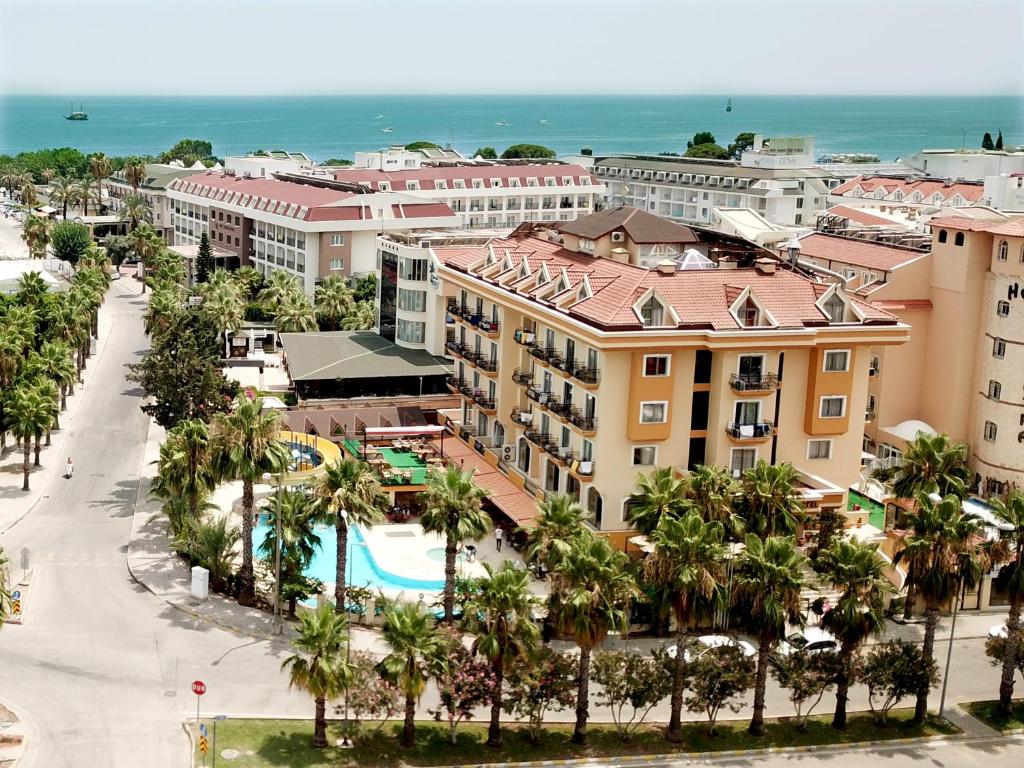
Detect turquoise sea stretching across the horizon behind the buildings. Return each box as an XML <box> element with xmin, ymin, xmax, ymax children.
<box><xmin>0</xmin><ymin>96</ymin><xmax>1024</xmax><ymax>160</ymax></box>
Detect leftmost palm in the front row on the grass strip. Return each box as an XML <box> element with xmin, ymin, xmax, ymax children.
<box><xmin>281</xmin><ymin>605</ymin><xmax>352</xmax><ymax>749</ymax></box>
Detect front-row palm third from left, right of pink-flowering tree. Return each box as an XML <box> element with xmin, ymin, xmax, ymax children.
<box><xmin>465</xmin><ymin>561</ymin><xmax>540</xmax><ymax>746</ymax></box>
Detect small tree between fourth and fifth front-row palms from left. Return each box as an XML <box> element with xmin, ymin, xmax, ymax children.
<box><xmin>591</xmin><ymin>651</ymin><xmax>682</xmax><ymax>741</ymax></box>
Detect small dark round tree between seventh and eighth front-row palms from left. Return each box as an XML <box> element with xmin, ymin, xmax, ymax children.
<box><xmin>861</xmin><ymin>640</ymin><xmax>939</xmax><ymax>725</ymax></box>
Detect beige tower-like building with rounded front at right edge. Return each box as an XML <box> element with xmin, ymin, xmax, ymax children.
<box><xmin>851</xmin><ymin>208</ymin><xmax>1024</xmax><ymax>495</ymax></box>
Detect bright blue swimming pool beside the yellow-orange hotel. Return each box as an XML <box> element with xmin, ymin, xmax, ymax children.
<box><xmin>253</xmin><ymin>515</ymin><xmax>444</xmax><ymax>593</ymax></box>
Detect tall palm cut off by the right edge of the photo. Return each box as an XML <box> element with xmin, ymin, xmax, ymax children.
<box><xmin>992</xmin><ymin>489</ymin><xmax>1024</xmax><ymax>717</ymax></box>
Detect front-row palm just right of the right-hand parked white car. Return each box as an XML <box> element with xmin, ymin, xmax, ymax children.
<box><xmin>815</xmin><ymin>539</ymin><xmax>890</xmax><ymax>729</ymax></box>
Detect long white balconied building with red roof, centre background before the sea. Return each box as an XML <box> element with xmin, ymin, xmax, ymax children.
<box><xmin>334</xmin><ymin>158</ymin><xmax>605</xmax><ymax>228</ymax></box>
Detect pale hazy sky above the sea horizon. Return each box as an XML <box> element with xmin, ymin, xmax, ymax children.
<box><xmin>0</xmin><ymin>0</ymin><xmax>1024</xmax><ymax>94</ymax></box>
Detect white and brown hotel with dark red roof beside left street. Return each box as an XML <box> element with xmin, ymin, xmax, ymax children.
<box><xmin>167</xmin><ymin>171</ymin><xmax>458</xmax><ymax>295</ymax></box>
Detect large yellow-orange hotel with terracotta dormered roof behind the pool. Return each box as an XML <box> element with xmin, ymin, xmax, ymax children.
<box><xmin>380</xmin><ymin>210</ymin><xmax>908</xmax><ymax>538</ymax></box>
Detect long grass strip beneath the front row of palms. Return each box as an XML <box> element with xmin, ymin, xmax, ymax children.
<box><xmin>198</xmin><ymin>710</ymin><xmax>958</xmax><ymax>768</ymax></box>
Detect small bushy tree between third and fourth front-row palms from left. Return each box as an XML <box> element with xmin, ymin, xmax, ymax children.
<box><xmin>505</xmin><ymin>645</ymin><xmax>580</xmax><ymax>743</ymax></box>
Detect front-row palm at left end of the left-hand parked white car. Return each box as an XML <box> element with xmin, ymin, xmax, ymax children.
<box><xmin>644</xmin><ymin>511</ymin><xmax>726</xmax><ymax>741</ymax></box>
